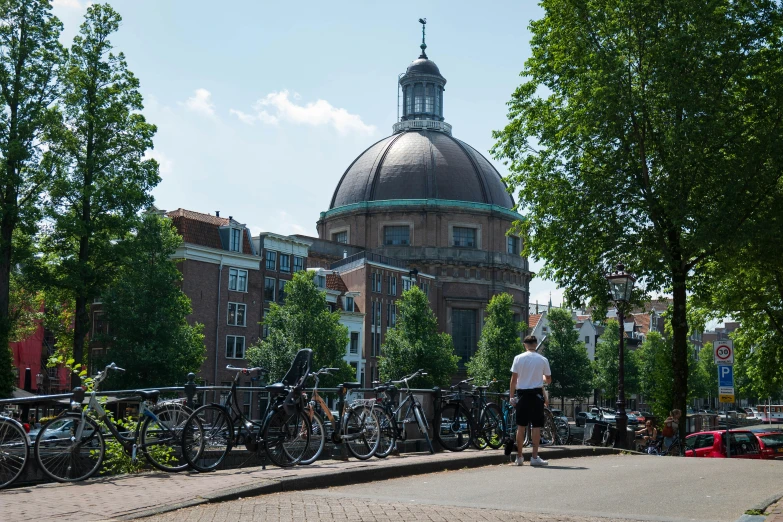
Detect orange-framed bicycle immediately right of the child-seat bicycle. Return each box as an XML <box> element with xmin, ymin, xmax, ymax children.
<box><xmin>299</xmin><ymin>368</ymin><xmax>381</xmax><ymax>464</ymax></box>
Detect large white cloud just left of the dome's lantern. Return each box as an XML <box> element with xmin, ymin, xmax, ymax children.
<box><xmin>229</xmin><ymin>91</ymin><xmax>375</xmax><ymax>134</ymax></box>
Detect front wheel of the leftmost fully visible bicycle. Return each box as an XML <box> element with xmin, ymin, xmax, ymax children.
<box><xmin>35</xmin><ymin>414</ymin><xmax>106</xmax><ymax>482</ymax></box>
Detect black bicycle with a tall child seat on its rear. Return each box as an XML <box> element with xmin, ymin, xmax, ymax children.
<box><xmin>183</xmin><ymin>349</ymin><xmax>313</xmax><ymax>472</ymax></box>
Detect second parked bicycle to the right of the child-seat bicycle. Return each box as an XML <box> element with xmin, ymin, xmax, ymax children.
<box><xmin>373</xmin><ymin>370</ymin><xmax>435</xmax><ymax>458</ymax></box>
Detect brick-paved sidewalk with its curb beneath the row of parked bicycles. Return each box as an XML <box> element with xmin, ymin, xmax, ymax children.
<box><xmin>0</xmin><ymin>446</ymin><xmax>615</xmax><ymax>522</ymax></box>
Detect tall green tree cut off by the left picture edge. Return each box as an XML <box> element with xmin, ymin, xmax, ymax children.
<box><xmin>0</xmin><ymin>0</ymin><xmax>64</xmax><ymax>397</ymax></box>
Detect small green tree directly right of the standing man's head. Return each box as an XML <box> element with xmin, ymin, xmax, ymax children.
<box><xmin>544</xmin><ymin>308</ymin><xmax>593</xmax><ymax>408</ymax></box>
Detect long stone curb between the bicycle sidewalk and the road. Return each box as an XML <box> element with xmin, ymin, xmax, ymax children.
<box><xmin>113</xmin><ymin>446</ymin><xmax>620</xmax><ymax>520</ymax></box>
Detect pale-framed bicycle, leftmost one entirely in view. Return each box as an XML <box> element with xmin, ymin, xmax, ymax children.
<box><xmin>35</xmin><ymin>363</ymin><xmax>200</xmax><ymax>482</ymax></box>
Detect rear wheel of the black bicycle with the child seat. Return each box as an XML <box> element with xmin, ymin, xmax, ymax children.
<box><xmin>264</xmin><ymin>407</ymin><xmax>310</xmax><ymax>468</ymax></box>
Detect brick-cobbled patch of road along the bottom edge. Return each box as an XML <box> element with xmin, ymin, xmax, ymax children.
<box><xmin>144</xmin><ymin>492</ymin><xmax>627</xmax><ymax>522</ymax></box>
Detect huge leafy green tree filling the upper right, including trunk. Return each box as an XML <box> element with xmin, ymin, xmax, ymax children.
<box><xmin>493</xmin><ymin>0</ymin><xmax>783</xmax><ymax>438</ymax></box>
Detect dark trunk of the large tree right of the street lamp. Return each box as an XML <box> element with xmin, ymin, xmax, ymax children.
<box><xmin>672</xmin><ymin>268</ymin><xmax>689</xmax><ymax>441</ymax></box>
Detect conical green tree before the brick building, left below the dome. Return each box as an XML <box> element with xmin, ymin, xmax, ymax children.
<box><xmin>378</xmin><ymin>286</ymin><xmax>460</xmax><ymax>387</ymax></box>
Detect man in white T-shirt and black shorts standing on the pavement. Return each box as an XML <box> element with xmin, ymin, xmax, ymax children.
<box><xmin>508</xmin><ymin>335</ymin><xmax>552</xmax><ymax>466</ymax></box>
